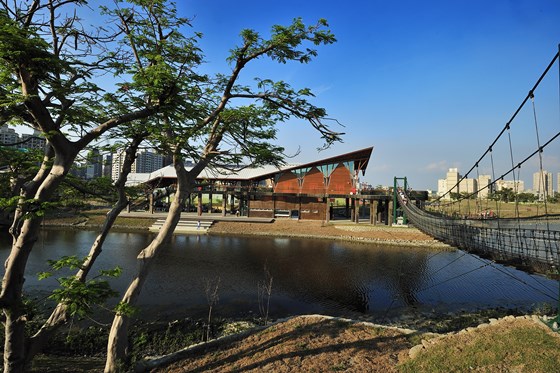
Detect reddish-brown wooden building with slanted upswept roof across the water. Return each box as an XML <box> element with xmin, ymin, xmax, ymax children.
<box><xmin>142</xmin><ymin>147</ymin><xmax>398</xmax><ymax>224</ymax></box>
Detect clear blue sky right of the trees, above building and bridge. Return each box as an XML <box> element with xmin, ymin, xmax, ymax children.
<box><xmin>177</xmin><ymin>0</ymin><xmax>560</xmax><ymax>189</ymax></box>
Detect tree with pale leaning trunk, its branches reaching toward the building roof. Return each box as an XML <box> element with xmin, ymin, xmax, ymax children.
<box><xmin>105</xmin><ymin>2</ymin><xmax>341</xmax><ymax>372</ymax></box>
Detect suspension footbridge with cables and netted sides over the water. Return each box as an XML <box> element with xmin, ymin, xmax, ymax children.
<box><xmin>395</xmin><ymin>46</ymin><xmax>560</xmax><ymax>276</ymax></box>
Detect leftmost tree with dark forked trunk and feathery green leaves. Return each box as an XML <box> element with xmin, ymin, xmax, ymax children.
<box><xmin>0</xmin><ymin>0</ymin><xmax>200</xmax><ymax>372</ymax></box>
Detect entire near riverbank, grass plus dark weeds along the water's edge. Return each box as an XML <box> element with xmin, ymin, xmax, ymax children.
<box><xmin>32</xmin><ymin>310</ymin><xmax>560</xmax><ymax>373</ymax></box>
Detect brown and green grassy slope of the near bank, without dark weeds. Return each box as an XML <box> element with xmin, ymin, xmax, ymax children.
<box><xmin>142</xmin><ymin>315</ymin><xmax>560</xmax><ymax>373</ymax></box>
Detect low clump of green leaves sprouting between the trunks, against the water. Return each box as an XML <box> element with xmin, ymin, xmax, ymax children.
<box><xmin>38</xmin><ymin>256</ymin><xmax>122</xmax><ymax>318</ymax></box>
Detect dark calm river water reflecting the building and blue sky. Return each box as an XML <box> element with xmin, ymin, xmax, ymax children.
<box><xmin>0</xmin><ymin>230</ymin><xmax>558</xmax><ymax>317</ymax></box>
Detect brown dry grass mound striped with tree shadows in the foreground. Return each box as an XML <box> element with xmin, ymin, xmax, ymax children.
<box><xmin>150</xmin><ymin>316</ymin><xmax>411</xmax><ymax>372</ymax></box>
